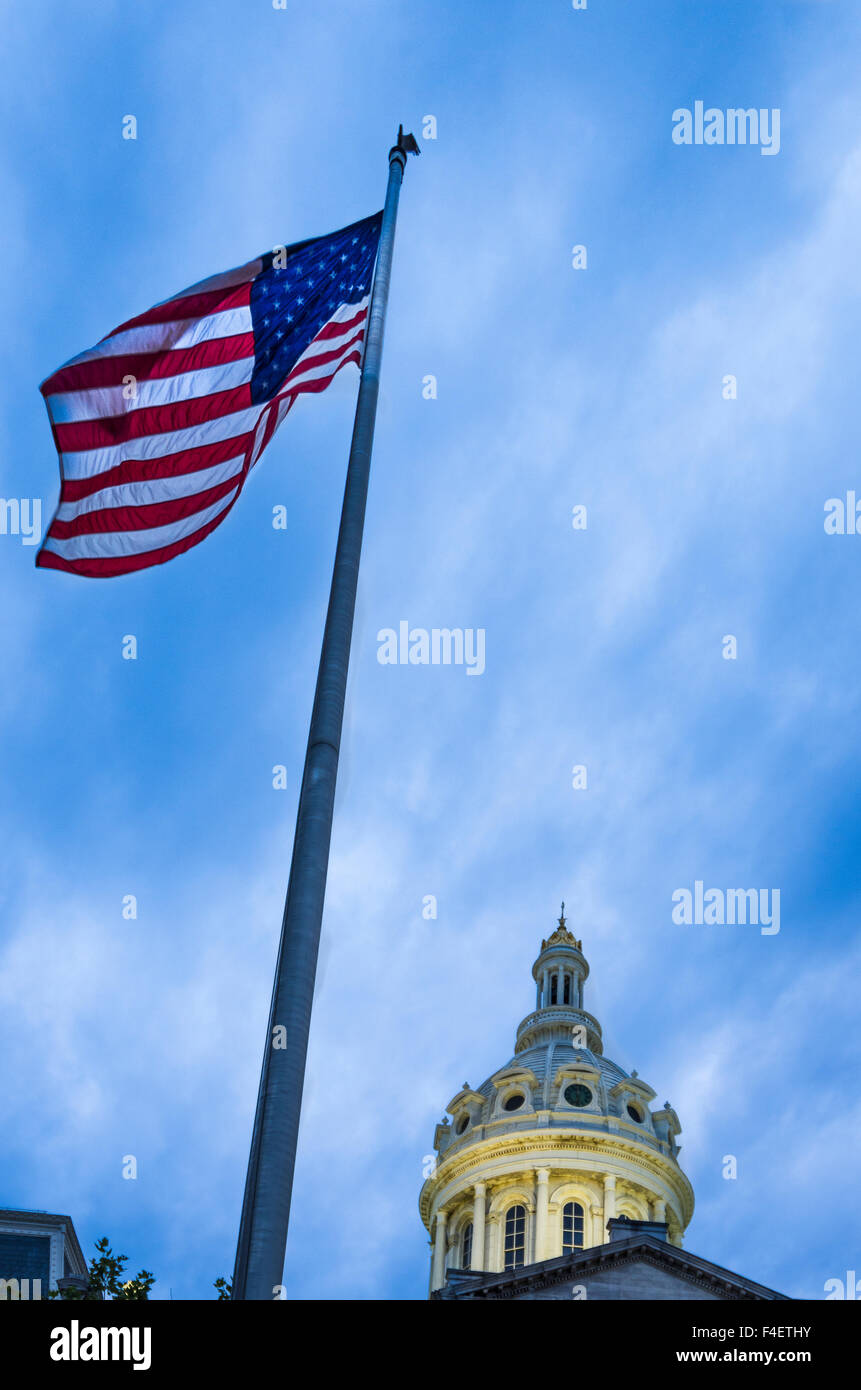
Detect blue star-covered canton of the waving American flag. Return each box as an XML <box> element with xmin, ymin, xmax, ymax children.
<box><xmin>250</xmin><ymin>213</ymin><xmax>383</xmax><ymax>404</ymax></box>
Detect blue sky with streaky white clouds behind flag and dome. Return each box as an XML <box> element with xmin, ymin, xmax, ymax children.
<box><xmin>0</xmin><ymin>0</ymin><xmax>861</xmax><ymax>1300</ymax></box>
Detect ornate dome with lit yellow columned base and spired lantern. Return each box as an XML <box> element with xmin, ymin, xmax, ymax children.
<box><xmin>420</xmin><ymin>904</ymin><xmax>694</xmax><ymax>1291</ymax></box>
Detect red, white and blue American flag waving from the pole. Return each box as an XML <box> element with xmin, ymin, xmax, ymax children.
<box><xmin>36</xmin><ymin>213</ymin><xmax>383</xmax><ymax>578</ymax></box>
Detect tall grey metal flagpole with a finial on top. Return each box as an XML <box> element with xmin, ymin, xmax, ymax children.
<box><xmin>232</xmin><ymin>128</ymin><xmax>419</xmax><ymax>1300</ymax></box>
